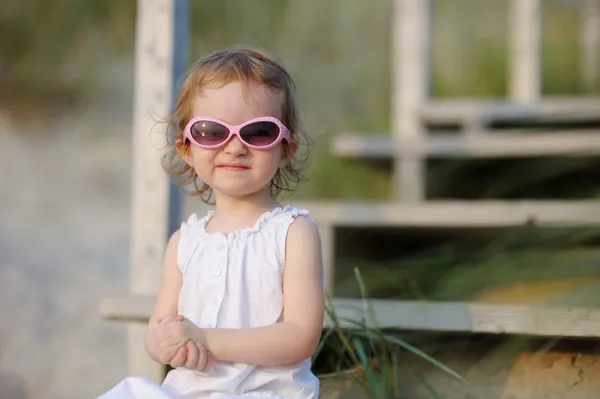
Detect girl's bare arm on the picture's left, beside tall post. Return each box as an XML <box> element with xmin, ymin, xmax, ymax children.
<box><xmin>144</xmin><ymin>230</ymin><xmax>182</xmax><ymax>363</ymax></box>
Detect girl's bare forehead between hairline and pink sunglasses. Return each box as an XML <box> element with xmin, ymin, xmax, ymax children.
<box><xmin>193</xmin><ymin>81</ymin><xmax>282</xmax><ymax>124</ymax></box>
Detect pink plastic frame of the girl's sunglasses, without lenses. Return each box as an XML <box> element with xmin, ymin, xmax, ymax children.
<box><xmin>183</xmin><ymin>116</ymin><xmax>291</xmax><ymax>150</ymax></box>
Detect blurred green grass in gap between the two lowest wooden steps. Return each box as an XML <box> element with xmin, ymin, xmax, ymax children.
<box><xmin>335</xmin><ymin>226</ymin><xmax>600</xmax><ymax>306</ymax></box>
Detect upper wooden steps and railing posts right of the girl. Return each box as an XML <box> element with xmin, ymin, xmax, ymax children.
<box><xmin>301</xmin><ymin>0</ymin><xmax>600</xmax><ymax>290</ymax></box>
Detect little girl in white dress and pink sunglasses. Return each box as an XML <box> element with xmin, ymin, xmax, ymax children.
<box><xmin>100</xmin><ymin>48</ymin><xmax>324</xmax><ymax>399</ymax></box>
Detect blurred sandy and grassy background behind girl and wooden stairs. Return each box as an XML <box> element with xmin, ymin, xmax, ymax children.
<box><xmin>0</xmin><ymin>0</ymin><xmax>600</xmax><ymax>399</ymax></box>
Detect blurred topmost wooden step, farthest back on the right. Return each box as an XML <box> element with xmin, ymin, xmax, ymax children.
<box><xmin>419</xmin><ymin>96</ymin><xmax>600</xmax><ymax>126</ymax></box>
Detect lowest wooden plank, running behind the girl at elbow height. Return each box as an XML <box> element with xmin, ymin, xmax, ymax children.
<box><xmin>101</xmin><ymin>296</ymin><xmax>600</xmax><ymax>337</ymax></box>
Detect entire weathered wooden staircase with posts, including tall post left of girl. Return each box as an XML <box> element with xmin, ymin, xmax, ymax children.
<box><xmin>100</xmin><ymin>0</ymin><xmax>600</xmax><ymax>380</ymax></box>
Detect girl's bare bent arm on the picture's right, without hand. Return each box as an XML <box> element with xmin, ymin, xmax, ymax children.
<box><xmin>199</xmin><ymin>217</ymin><xmax>325</xmax><ymax>366</ymax></box>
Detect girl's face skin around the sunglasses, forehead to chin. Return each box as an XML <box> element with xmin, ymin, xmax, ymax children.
<box><xmin>184</xmin><ymin>82</ymin><xmax>294</xmax><ymax>197</ymax></box>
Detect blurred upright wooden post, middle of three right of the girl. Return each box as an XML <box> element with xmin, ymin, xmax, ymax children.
<box><xmin>508</xmin><ymin>0</ymin><xmax>542</xmax><ymax>103</ymax></box>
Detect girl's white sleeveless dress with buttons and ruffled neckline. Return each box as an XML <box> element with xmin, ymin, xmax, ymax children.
<box><xmin>99</xmin><ymin>205</ymin><xmax>319</xmax><ymax>399</ymax></box>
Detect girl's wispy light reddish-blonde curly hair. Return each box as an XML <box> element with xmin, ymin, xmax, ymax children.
<box><xmin>162</xmin><ymin>47</ymin><xmax>310</xmax><ymax>204</ymax></box>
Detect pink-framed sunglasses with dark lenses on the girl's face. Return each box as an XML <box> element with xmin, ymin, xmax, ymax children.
<box><xmin>183</xmin><ymin>116</ymin><xmax>290</xmax><ymax>150</ymax></box>
